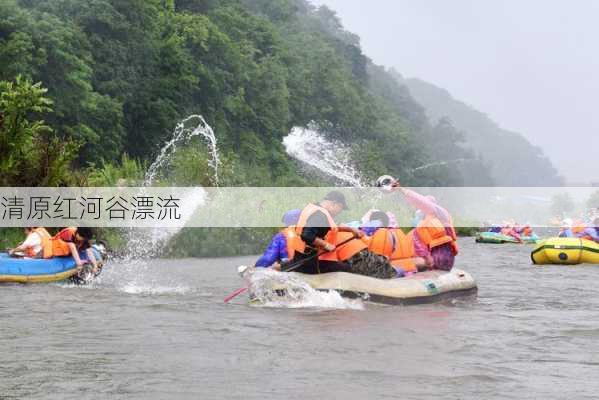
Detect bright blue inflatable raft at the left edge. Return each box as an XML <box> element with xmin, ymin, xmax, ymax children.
<box><xmin>0</xmin><ymin>245</ymin><xmax>103</xmax><ymax>283</ymax></box>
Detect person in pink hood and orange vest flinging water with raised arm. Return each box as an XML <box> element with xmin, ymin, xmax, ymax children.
<box><xmin>377</xmin><ymin>175</ymin><xmax>458</xmax><ymax>271</ymax></box>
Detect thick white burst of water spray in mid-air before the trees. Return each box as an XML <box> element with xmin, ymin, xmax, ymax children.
<box><xmin>283</xmin><ymin>123</ymin><xmax>364</xmax><ymax>187</ymax></box>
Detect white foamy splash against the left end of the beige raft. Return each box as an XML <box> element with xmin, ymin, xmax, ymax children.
<box><xmin>248</xmin><ymin>269</ymin><xmax>364</xmax><ymax>310</ymax></box>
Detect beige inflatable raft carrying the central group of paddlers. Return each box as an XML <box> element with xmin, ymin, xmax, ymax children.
<box><xmin>250</xmin><ymin>269</ymin><xmax>477</xmax><ymax>305</ymax></box>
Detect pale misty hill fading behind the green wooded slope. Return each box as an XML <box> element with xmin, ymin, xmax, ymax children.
<box><xmin>394</xmin><ymin>73</ymin><xmax>562</xmax><ymax>186</ymax></box>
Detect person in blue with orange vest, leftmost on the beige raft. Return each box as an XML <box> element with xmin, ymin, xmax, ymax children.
<box><xmin>255</xmin><ymin>210</ymin><xmax>302</xmax><ymax>270</ymax></box>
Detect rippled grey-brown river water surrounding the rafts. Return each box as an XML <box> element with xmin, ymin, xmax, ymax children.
<box><xmin>0</xmin><ymin>238</ymin><xmax>599</xmax><ymax>400</ymax></box>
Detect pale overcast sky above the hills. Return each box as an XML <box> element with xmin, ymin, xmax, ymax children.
<box><xmin>312</xmin><ymin>0</ymin><xmax>599</xmax><ymax>182</ymax></box>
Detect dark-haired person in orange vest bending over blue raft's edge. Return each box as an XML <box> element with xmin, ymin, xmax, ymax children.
<box><xmin>51</xmin><ymin>227</ymin><xmax>98</xmax><ymax>274</ymax></box>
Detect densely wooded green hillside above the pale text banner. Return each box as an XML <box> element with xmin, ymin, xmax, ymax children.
<box><xmin>0</xmin><ymin>0</ymin><xmax>506</xmax><ymax>185</ymax></box>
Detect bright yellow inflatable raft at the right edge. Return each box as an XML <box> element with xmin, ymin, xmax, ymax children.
<box><xmin>530</xmin><ymin>238</ymin><xmax>599</xmax><ymax>265</ymax></box>
